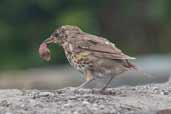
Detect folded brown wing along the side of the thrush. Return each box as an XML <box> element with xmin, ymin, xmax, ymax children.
<box><xmin>73</xmin><ymin>33</ymin><xmax>135</xmax><ymax>59</ymax></box>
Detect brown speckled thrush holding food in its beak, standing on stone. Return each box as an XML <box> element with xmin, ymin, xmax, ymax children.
<box><xmin>39</xmin><ymin>25</ymin><xmax>136</xmax><ymax>91</ymax></box>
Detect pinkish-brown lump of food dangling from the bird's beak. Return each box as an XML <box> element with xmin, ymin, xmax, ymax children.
<box><xmin>39</xmin><ymin>42</ymin><xmax>51</xmax><ymax>61</ymax></box>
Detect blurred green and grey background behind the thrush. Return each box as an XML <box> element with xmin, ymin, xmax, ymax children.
<box><xmin>0</xmin><ymin>0</ymin><xmax>171</xmax><ymax>89</ymax></box>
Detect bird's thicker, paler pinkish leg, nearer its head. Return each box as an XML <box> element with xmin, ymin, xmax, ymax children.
<box><xmin>78</xmin><ymin>71</ymin><xmax>94</xmax><ymax>89</ymax></box>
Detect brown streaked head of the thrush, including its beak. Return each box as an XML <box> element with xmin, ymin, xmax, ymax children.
<box><xmin>44</xmin><ymin>25</ymin><xmax>81</xmax><ymax>44</ymax></box>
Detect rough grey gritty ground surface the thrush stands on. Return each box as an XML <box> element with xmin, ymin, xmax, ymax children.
<box><xmin>0</xmin><ymin>82</ymin><xmax>171</xmax><ymax>114</ymax></box>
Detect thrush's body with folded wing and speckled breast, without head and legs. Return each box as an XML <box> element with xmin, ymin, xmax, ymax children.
<box><xmin>62</xmin><ymin>33</ymin><xmax>134</xmax><ymax>74</ymax></box>
